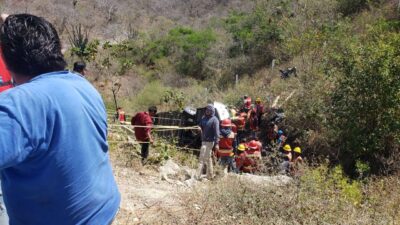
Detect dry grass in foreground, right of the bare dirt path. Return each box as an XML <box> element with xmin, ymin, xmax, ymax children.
<box><xmin>173</xmin><ymin>167</ymin><xmax>400</xmax><ymax>225</ymax></box>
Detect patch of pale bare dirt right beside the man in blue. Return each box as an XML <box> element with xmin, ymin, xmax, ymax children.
<box><xmin>111</xmin><ymin>149</ymin><xmax>190</xmax><ymax>225</ymax></box>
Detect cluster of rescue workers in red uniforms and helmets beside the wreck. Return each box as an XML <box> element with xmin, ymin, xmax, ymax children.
<box><xmin>215</xmin><ymin>96</ymin><xmax>303</xmax><ymax>178</ymax></box>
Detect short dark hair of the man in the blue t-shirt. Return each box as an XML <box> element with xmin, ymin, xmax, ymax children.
<box><xmin>0</xmin><ymin>14</ymin><xmax>67</xmax><ymax>77</ymax></box>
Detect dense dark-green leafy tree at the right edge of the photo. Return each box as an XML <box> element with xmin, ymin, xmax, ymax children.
<box><xmin>331</xmin><ymin>25</ymin><xmax>400</xmax><ymax>172</ymax></box>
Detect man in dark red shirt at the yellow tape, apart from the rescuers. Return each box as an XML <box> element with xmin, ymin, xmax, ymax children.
<box><xmin>131</xmin><ymin>106</ymin><xmax>157</xmax><ymax>165</ymax></box>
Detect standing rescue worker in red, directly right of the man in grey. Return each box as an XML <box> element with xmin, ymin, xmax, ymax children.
<box><xmin>217</xmin><ymin>119</ymin><xmax>235</xmax><ymax>173</ymax></box>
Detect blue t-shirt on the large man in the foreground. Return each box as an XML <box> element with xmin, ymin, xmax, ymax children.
<box><xmin>0</xmin><ymin>71</ymin><xmax>120</xmax><ymax>225</ymax></box>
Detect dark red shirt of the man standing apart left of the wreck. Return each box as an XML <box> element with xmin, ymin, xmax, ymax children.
<box><xmin>131</xmin><ymin>112</ymin><xmax>153</xmax><ymax>141</ymax></box>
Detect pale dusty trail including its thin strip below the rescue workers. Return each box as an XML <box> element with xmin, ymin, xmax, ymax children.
<box><xmin>110</xmin><ymin>140</ymin><xmax>291</xmax><ymax>225</ymax></box>
